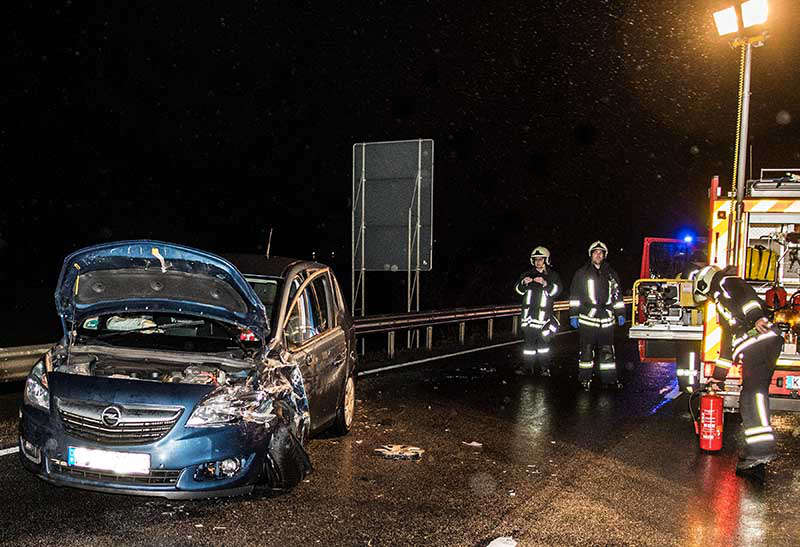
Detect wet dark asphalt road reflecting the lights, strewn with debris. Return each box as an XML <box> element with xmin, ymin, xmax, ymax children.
<box><xmin>0</xmin><ymin>335</ymin><xmax>800</xmax><ymax>545</ymax></box>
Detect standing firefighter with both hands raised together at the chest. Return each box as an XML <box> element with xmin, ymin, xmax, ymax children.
<box><xmin>515</xmin><ymin>246</ymin><xmax>563</xmax><ymax>376</ymax></box>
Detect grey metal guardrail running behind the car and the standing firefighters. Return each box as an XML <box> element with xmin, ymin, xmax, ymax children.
<box><xmin>0</xmin><ymin>297</ymin><xmax>631</xmax><ymax>382</ymax></box>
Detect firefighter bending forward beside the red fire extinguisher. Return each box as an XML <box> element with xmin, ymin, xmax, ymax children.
<box><xmin>692</xmin><ymin>266</ymin><xmax>783</xmax><ymax>478</ymax></box>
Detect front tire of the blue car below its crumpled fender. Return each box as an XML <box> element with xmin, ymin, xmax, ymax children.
<box><xmin>262</xmin><ymin>427</ymin><xmax>311</xmax><ymax>492</ymax></box>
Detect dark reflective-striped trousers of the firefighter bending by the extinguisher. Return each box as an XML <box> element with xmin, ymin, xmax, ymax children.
<box><xmin>739</xmin><ymin>336</ymin><xmax>783</xmax><ymax>458</ymax></box>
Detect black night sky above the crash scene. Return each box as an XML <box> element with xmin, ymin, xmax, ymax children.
<box><xmin>0</xmin><ymin>0</ymin><xmax>800</xmax><ymax>345</ymax></box>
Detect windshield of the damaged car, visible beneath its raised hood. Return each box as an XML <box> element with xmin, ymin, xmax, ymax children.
<box><xmin>78</xmin><ymin>312</ymin><xmax>258</xmax><ymax>353</ymax></box>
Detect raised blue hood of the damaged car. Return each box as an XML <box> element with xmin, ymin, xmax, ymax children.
<box><xmin>55</xmin><ymin>240</ymin><xmax>269</xmax><ymax>341</ymax></box>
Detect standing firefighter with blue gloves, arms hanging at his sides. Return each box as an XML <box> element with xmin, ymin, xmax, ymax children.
<box><xmin>569</xmin><ymin>241</ymin><xmax>625</xmax><ymax>391</ymax></box>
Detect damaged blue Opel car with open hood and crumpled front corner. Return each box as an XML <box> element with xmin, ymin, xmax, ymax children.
<box><xmin>19</xmin><ymin>241</ymin><xmax>355</xmax><ymax>499</ymax></box>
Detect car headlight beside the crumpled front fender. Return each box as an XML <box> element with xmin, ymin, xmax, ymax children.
<box><xmin>186</xmin><ymin>386</ymin><xmax>275</xmax><ymax>427</ymax></box>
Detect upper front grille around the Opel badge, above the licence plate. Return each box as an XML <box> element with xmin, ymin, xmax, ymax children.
<box><xmin>56</xmin><ymin>398</ymin><xmax>183</xmax><ymax>445</ymax></box>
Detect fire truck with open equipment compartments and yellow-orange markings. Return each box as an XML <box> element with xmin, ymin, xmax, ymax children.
<box><xmin>629</xmin><ymin>169</ymin><xmax>800</xmax><ymax>411</ymax></box>
